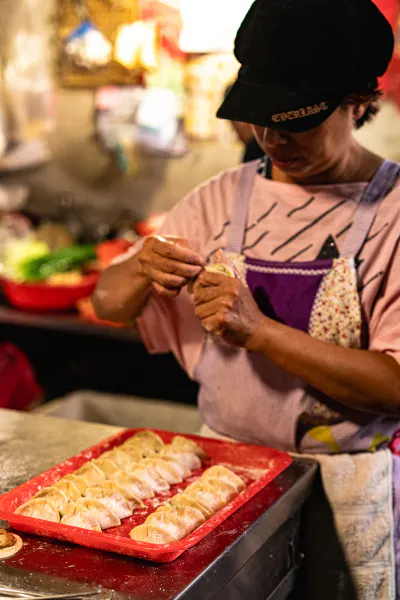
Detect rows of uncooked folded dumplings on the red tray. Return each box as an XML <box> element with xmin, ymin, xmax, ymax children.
<box><xmin>16</xmin><ymin>430</ymin><xmax>222</xmax><ymax>543</ymax></box>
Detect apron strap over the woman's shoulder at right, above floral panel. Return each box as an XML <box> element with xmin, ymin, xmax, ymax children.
<box><xmin>341</xmin><ymin>160</ymin><xmax>400</xmax><ymax>258</ymax></box>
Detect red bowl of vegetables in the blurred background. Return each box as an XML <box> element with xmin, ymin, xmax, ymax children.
<box><xmin>3</xmin><ymin>273</ymin><xmax>99</xmax><ymax>312</ymax></box>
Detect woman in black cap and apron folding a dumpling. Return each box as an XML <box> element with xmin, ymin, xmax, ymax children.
<box><xmin>95</xmin><ymin>0</ymin><xmax>400</xmax><ymax>600</ymax></box>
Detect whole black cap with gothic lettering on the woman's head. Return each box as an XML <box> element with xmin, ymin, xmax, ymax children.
<box><xmin>217</xmin><ymin>0</ymin><xmax>394</xmax><ymax>132</ymax></box>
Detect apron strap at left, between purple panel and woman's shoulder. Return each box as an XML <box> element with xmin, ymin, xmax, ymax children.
<box><xmin>226</xmin><ymin>160</ymin><xmax>259</xmax><ymax>254</ymax></box>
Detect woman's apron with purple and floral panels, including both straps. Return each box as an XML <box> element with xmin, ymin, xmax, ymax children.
<box><xmin>194</xmin><ymin>161</ymin><xmax>400</xmax><ymax>454</ymax></box>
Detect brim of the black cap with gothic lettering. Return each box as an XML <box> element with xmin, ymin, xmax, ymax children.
<box><xmin>217</xmin><ymin>79</ymin><xmax>346</xmax><ymax>133</ymax></box>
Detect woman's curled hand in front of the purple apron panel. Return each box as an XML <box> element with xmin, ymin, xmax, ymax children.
<box><xmin>193</xmin><ymin>271</ymin><xmax>266</xmax><ymax>350</ymax></box>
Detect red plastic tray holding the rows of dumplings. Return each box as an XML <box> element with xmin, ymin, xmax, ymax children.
<box><xmin>0</xmin><ymin>429</ymin><xmax>292</xmax><ymax>563</ymax></box>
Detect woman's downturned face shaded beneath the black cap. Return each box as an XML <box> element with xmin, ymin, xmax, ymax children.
<box><xmin>252</xmin><ymin>106</ymin><xmax>366</xmax><ymax>181</ymax></box>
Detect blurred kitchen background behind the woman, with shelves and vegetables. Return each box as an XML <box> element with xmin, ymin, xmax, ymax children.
<box><xmin>0</xmin><ymin>0</ymin><xmax>400</xmax><ymax>431</ymax></box>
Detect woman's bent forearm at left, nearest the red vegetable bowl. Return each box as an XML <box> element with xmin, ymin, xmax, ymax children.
<box><xmin>93</xmin><ymin>256</ymin><xmax>151</xmax><ymax>323</ymax></box>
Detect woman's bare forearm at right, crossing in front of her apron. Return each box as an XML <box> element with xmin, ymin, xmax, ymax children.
<box><xmin>249</xmin><ymin>319</ymin><xmax>400</xmax><ymax>415</ymax></box>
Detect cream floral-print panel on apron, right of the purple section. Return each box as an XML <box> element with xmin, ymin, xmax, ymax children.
<box><xmin>308</xmin><ymin>258</ymin><xmax>362</xmax><ymax>348</ymax></box>
